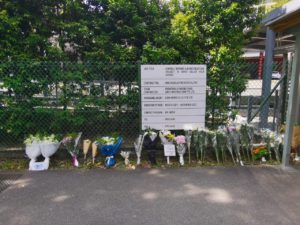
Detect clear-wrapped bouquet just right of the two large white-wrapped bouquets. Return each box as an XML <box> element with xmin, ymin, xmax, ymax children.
<box><xmin>62</xmin><ymin>132</ymin><xmax>82</xmax><ymax>167</ymax></box>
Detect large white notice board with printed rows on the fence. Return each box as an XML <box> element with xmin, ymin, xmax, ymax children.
<box><xmin>141</xmin><ymin>65</ymin><xmax>206</xmax><ymax>130</ymax></box>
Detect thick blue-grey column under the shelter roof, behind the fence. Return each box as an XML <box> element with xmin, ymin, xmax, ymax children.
<box><xmin>259</xmin><ymin>28</ymin><xmax>275</xmax><ymax>128</ymax></box>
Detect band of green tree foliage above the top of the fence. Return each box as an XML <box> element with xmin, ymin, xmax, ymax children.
<box><xmin>0</xmin><ymin>0</ymin><xmax>259</xmax><ymax>63</ymax></box>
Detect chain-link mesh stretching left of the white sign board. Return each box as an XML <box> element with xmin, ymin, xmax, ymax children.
<box><xmin>0</xmin><ymin>62</ymin><xmax>139</xmax><ymax>147</ymax></box>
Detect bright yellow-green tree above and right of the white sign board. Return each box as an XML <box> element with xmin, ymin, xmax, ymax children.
<box><xmin>164</xmin><ymin>0</ymin><xmax>260</xmax><ymax>123</ymax></box>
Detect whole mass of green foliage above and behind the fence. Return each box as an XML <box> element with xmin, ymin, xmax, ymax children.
<box><xmin>0</xmin><ymin>0</ymin><xmax>259</xmax><ymax>138</ymax></box>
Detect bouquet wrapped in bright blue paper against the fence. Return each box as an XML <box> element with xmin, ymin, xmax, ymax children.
<box><xmin>96</xmin><ymin>135</ymin><xmax>123</xmax><ymax>168</ymax></box>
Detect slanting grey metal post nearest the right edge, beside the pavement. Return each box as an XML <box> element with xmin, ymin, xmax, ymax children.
<box><xmin>282</xmin><ymin>33</ymin><xmax>300</xmax><ymax>167</ymax></box>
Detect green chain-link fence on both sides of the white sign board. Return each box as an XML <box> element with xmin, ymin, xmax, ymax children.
<box><xmin>0</xmin><ymin>61</ymin><xmax>286</xmax><ymax>150</ymax></box>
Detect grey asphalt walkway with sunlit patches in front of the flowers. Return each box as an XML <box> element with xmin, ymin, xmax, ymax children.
<box><xmin>0</xmin><ymin>167</ymin><xmax>300</xmax><ymax>225</ymax></box>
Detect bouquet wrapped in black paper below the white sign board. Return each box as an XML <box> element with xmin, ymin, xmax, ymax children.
<box><xmin>142</xmin><ymin>128</ymin><xmax>158</xmax><ymax>165</ymax></box>
